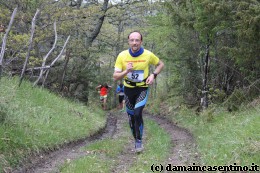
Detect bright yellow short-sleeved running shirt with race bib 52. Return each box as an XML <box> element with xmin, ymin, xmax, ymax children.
<box><xmin>115</xmin><ymin>49</ymin><xmax>159</xmax><ymax>88</ymax></box>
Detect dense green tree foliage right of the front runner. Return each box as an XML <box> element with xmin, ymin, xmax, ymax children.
<box><xmin>145</xmin><ymin>0</ymin><xmax>260</xmax><ymax>107</ymax></box>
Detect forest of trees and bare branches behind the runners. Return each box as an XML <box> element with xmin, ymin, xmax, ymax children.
<box><xmin>0</xmin><ymin>0</ymin><xmax>260</xmax><ymax>172</ymax></box>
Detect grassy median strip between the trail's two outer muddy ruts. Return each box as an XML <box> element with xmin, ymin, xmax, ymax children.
<box><xmin>61</xmin><ymin>119</ymin><xmax>170</xmax><ymax>173</ymax></box>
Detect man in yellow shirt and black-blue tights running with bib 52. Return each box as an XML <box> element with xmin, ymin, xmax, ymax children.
<box><xmin>113</xmin><ymin>31</ymin><xmax>164</xmax><ymax>152</ymax></box>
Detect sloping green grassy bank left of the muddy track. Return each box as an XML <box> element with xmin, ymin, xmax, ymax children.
<box><xmin>0</xmin><ymin>78</ymin><xmax>106</xmax><ymax>170</ymax></box>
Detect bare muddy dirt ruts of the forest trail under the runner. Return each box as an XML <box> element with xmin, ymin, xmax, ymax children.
<box><xmin>13</xmin><ymin>111</ymin><xmax>198</xmax><ymax>173</ymax></box>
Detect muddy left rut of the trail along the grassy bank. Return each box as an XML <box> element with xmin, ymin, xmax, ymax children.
<box><xmin>12</xmin><ymin>113</ymin><xmax>117</xmax><ymax>173</ymax></box>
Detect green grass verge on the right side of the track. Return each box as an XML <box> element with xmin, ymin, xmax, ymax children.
<box><xmin>171</xmin><ymin>105</ymin><xmax>260</xmax><ymax>166</ymax></box>
